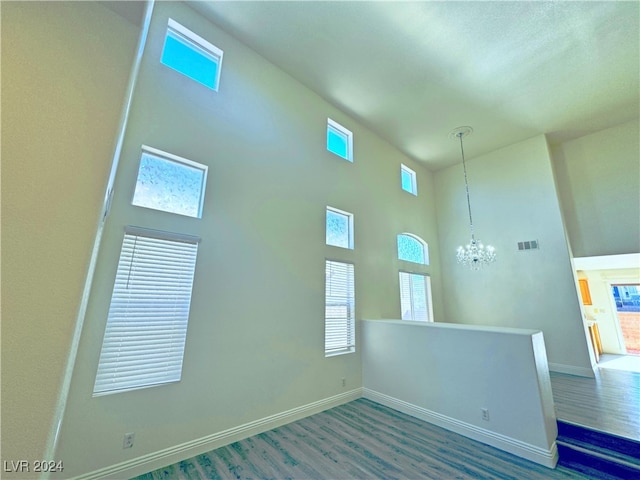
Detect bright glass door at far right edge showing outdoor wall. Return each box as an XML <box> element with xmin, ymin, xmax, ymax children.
<box><xmin>611</xmin><ymin>283</ymin><xmax>640</xmax><ymax>355</ymax></box>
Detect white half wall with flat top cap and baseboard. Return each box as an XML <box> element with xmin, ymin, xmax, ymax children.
<box><xmin>362</xmin><ymin>320</ymin><xmax>557</xmax><ymax>467</ymax></box>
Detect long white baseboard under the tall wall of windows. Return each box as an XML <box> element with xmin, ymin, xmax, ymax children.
<box><xmin>75</xmin><ymin>388</ymin><xmax>362</xmax><ymax>480</ymax></box>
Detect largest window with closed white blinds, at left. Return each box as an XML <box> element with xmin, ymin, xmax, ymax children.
<box><xmin>93</xmin><ymin>227</ymin><xmax>199</xmax><ymax>396</ymax></box>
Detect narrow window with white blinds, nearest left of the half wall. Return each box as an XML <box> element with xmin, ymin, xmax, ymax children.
<box><xmin>324</xmin><ymin>260</ymin><xmax>355</xmax><ymax>357</ymax></box>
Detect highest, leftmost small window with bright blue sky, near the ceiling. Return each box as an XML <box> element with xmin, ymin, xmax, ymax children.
<box><xmin>160</xmin><ymin>18</ymin><xmax>223</xmax><ymax>91</ymax></box>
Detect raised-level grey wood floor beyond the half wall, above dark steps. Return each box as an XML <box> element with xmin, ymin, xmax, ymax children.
<box><xmin>551</xmin><ymin>368</ymin><xmax>640</xmax><ymax>441</ymax></box>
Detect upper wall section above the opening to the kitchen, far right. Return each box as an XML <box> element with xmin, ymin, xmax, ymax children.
<box><xmin>552</xmin><ymin>119</ymin><xmax>640</xmax><ymax>257</ymax></box>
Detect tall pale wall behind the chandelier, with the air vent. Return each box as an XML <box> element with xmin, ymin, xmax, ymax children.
<box><xmin>435</xmin><ymin>134</ymin><xmax>593</xmax><ymax>375</ymax></box>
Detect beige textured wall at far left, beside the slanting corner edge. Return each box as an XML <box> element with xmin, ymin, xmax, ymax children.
<box><xmin>0</xmin><ymin>2</ymin><xmax>137</xmax><ymax>470</ymax></box>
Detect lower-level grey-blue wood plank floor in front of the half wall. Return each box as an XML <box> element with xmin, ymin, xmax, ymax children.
<box><xmin>137</xmin><ymin>399</ymin><xmax>596</xmax><ymax>480</ymax></box>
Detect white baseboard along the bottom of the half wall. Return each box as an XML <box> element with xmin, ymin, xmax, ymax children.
<box><xmin>362</xmin><ymin>388</ymin><xmax>558</xmax><ymax>468</ymax></box>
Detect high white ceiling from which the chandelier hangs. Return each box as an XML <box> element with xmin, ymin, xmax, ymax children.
<box><xmin>112</xmin><ymin>1</ymin><xmax>640</xmax><ymax>170</ymax></box>
